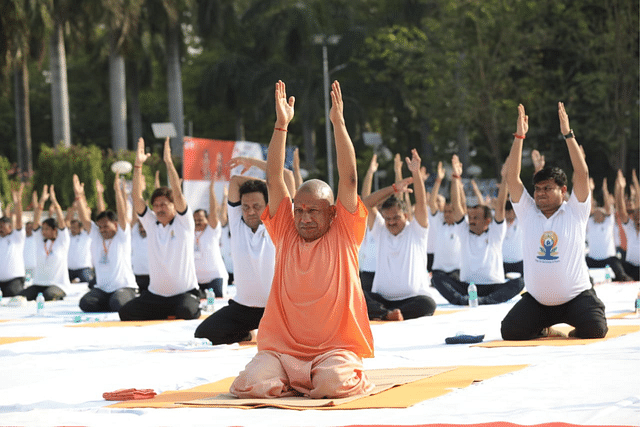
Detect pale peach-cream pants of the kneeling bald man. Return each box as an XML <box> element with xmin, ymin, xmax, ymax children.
<box><xmin>229</xmin><ymin>350</ymin><xmax>374</xmax><ymax>399</ymax></box>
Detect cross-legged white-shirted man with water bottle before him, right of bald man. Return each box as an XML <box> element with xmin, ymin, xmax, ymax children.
<box><xmin>431</xmin><ymin>155</ymin><xmax>524</xmax><ymax>305</ymax></box>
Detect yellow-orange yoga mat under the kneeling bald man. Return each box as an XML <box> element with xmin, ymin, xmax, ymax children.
<box><xmin>108</xmin><ymin>365</ymin><xmax>527</xmax><ymax>410</ymax></box>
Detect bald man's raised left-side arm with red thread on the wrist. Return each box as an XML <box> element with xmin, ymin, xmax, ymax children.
<box><xmin>267</xmin><ymin>80</ymin><xmax>295</xmax><ymax>216</ymax></box>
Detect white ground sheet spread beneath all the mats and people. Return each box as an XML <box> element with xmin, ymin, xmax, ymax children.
<box><xmin>0</xmin><ymin>276</ymin><xmax>640</xmax><ymax>427</ymax></box>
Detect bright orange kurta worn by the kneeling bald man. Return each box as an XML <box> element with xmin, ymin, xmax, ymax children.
<box><xmin>258</xmin><ymin>198</ymin><xmax>373</xmax><ymax>360</ymax></box>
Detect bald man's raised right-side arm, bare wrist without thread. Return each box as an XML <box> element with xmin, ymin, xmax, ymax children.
<box><xmin>330</xmin><ymin>81</ymin><xmax>358</xmax><ymax>213</ymax></box>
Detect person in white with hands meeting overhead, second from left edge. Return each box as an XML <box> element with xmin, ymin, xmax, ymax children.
<box><xmin>19</xmin><ymin>185</ymin><xmax>71</xmax><ymax>301</ymax></box>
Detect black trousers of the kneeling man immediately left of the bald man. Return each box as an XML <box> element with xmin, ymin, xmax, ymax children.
<box><xmin>194</xmin><ymin>300</ymin><xmax>264</xmax><ymax>345</ymax></box>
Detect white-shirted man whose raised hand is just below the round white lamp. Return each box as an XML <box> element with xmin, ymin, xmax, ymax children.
<box><xmin>73</xmin><ymin>174</ymin><xmax>137</xmax><ymax>313</ymax></box>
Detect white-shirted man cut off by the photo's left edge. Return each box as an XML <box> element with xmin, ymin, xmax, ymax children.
<box><xmin>0</xmin><ymin>183</ymin><xmax>26</xmax><ymax>297</ymax></box>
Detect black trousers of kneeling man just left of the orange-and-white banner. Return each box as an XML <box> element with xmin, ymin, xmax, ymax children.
<box><xmin>118</xmin><ymin>289</ymin><xmax>200</xmax><ymax>320</ymax></box>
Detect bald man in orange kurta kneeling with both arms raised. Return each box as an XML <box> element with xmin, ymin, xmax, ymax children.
<box><xmin>230</xmin><ymin>82</ymin><xmax>373</xmax><ymax>398</ymax></box>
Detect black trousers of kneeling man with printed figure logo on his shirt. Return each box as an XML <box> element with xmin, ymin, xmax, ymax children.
<box><xmin>501</xmin><ymin>288</ymin><xmax>608</xmax><ymax>340</ymax></box>
